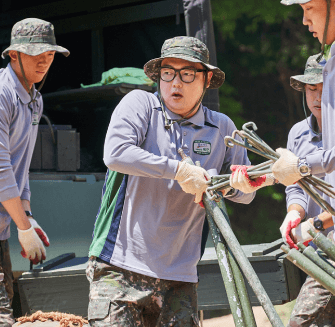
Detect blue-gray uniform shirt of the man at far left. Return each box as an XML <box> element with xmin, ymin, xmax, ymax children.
<box><xmin>0</xmin><ymin>64</ymin><xmax>43</xmax><ymax>240</ymax></box>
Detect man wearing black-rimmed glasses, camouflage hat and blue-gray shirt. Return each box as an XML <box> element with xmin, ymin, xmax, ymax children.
<box><xmin>86</xmin><ymin>36</ymin><xmax>254</xmax><ymax>327</ymax></box>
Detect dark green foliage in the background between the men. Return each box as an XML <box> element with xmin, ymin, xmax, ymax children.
<box><xmin>211</xmin><ymin>0</ymin><xmax>320</xmax><ymax>244</ymax></box>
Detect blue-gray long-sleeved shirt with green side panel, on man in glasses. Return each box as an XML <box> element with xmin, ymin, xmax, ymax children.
<box><xmin>90</xmin><ymin>90</ymin><xmax>254</xmax><ymax>282</ymax></box>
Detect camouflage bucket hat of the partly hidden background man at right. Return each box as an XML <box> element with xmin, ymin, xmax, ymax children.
<box><xmin>290</xmin><ymin>54</ymin><xmax>323</xmax><ymax>92</ymax></box>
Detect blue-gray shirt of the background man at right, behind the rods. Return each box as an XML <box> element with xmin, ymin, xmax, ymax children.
<box><xmin>286</xmin><ymin>115</ymin><xmax>325</xmax><ymax>218</ymax></box>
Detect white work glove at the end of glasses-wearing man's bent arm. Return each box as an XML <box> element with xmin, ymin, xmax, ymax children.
<box><xmin>174</xmin><ymin>161</ymin><xmax>210</xmax><ymax>203</ymax></box>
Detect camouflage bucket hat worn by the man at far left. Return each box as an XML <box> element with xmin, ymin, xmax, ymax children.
<box><xmin>1</xmin><ymin>18</ymin><xmax>70</xmax><ymax>59</ymax></box>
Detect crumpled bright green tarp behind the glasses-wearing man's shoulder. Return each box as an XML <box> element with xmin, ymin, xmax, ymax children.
<box><xmin>80</xmin><ymin>67</ymin><xmax>156</xmax><ymax>88</ymax></box>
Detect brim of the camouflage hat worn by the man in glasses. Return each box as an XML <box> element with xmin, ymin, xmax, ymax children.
<box><xmin>143</xmin><ymin>54</ymin><xmax>225</xmax><ymax>89</ymax></box>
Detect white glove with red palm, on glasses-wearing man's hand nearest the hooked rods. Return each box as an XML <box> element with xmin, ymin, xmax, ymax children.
<box><xmin>230</xmin><ymin>165</ymin><xmax>275</xmax><ymax>193</ymax></box>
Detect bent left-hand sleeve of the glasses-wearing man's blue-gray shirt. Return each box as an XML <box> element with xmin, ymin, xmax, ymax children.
<box><xmin>104</xmin><ymin>91</ymin><xmax>178</xmax><ymax>179</ymax></box>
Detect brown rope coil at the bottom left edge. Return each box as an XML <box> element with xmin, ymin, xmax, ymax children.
<box><xmin>17</xmin><ymin>311</ymin><xmax>88</xmax><ymax>327</ymax></box>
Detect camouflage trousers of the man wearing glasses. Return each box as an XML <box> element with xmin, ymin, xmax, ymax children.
<box><xmin>86</xmin><ymin>257</ymin><xmax>200</xmax><ymax>327</ymax></box>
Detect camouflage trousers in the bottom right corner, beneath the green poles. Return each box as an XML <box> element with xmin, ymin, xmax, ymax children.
<box><xmin>287</xmin><ymin>231</ymin><xmax>335</xmax><ymax>327</ymax></box>
